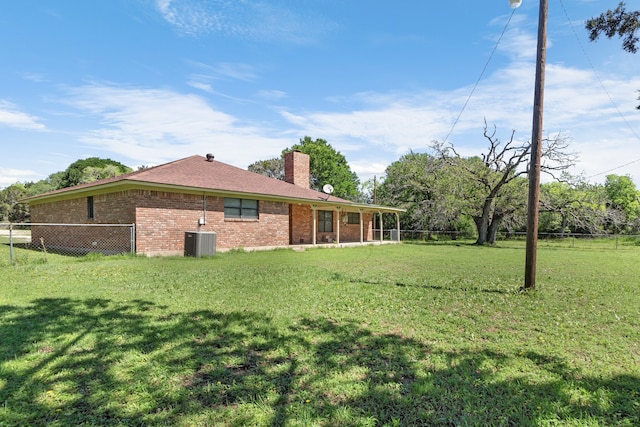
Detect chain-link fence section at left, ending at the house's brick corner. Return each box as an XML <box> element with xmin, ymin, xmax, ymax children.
<box><xmin>0</xmin><ymin>223</ymin><xmax>135</xmax><ymax>263</ymax></box>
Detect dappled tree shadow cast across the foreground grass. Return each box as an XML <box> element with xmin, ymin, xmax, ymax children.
<box><xmin>0</xmin><ymin>298</ymin><xmax>640</xmax><ymax>426</ymax></box>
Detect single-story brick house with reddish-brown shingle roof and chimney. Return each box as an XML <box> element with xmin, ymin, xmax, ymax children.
<box><xmin>25</xmin><ymin>151</ymin><xmax>403</xmax><ymax>255</ymax></box>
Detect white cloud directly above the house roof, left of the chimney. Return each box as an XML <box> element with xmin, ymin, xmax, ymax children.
<box><xmin>63</xmin><ymin>85</ymin><xmax>290</xmax><ymax>167</ymax></box>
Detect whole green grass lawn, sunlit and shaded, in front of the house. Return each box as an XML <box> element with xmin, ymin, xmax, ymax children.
<box><xmin>0</xmin><ymin>244</ymin><xmax>640</xmax><ymax>426</ymax></box>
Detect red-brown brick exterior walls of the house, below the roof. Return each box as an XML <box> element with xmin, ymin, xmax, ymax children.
<box><xmin>31</xmin><ymin>190</ymin><xmax>373</xmax><ymax>255</ymax></box>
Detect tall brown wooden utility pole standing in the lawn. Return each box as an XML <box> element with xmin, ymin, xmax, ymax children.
<box><xmin>524</xmin><ymin>0</ymin><xmax>549</xmax><ymax>289</ymax></box>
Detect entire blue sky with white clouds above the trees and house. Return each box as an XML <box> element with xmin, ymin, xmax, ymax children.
<box><xmin>0</xmin><ymin>0</ymin><xmax>640</xmax><ymax>187</ymax></box>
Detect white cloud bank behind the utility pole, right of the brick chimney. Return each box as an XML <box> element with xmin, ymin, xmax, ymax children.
<box><xmin>281</xmin><ymin>57</ymin><xmax>640</xmax><ymax>186</ymax></box>
